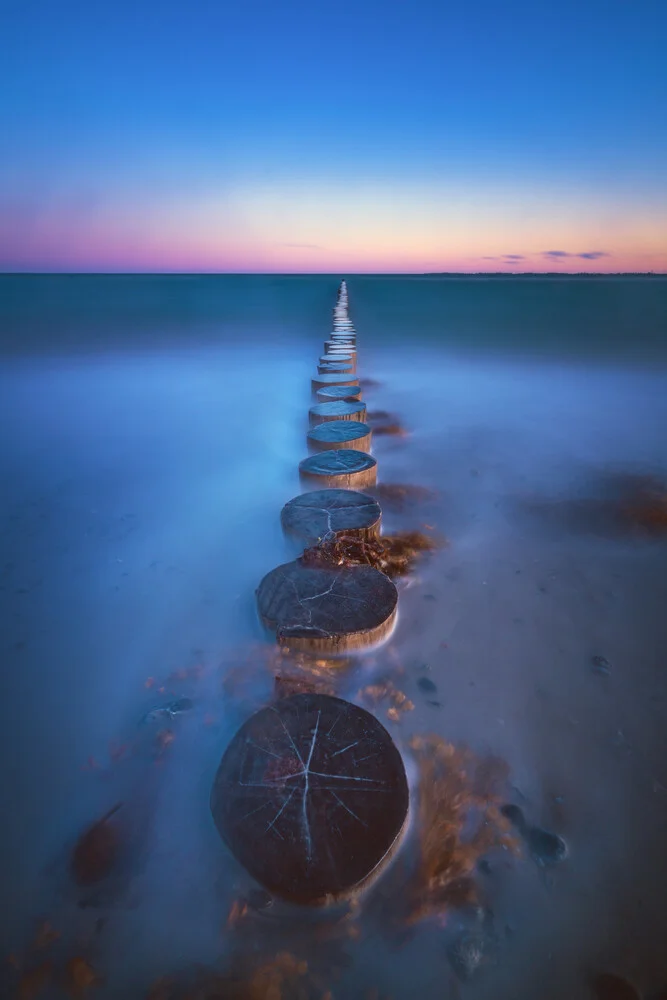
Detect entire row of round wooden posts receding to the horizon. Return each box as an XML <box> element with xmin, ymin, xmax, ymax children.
<box><xmin>211</xmin><ymin>281</ymin><xmax>409</xmax><ymax>905</ymax></box>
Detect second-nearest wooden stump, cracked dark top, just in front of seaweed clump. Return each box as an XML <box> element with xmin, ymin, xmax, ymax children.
<box><xmin>257</xmin><ymin>560</ymin><xmax>398</xmax><ymax>654</ymax></box>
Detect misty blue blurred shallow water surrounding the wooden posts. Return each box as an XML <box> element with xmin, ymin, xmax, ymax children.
<box><xmin>0</xmin><ymin>278</ymin><xmax>667</xmax><ymax>1000</ymax></box>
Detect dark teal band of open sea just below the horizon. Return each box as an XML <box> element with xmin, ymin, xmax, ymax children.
<box><xmin>0</xmin><ymin>275</ymin><xmax>667</xmax><ymax>362</ymax></box>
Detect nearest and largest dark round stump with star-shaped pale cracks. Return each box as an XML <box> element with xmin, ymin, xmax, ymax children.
<box><xmin>211</xmin><ymin>694</ymin><xmax>409</xmax><ymax>905</ymax></box>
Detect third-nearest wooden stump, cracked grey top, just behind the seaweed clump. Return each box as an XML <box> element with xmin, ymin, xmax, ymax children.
<box><xmin>280</xmin><ymin>490</ymin><xmax>382</xmax><ymax>545</ymax></box>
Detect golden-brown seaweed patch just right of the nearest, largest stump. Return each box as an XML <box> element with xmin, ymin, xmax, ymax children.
<box><xmin>406</xmin><ymin>736</ymin><xmax>519</xmax><ymax>923</ymax></box>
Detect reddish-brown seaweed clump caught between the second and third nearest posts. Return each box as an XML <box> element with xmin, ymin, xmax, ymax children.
<box><xmin>301</xmin><ymin>531</ymin><xmax>438</xmax><ymax>577</ymax></box>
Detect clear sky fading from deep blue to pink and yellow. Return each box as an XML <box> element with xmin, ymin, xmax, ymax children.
<box><xmin>0</xmin><ymin>0</ymin><xmax>667</xmax><ymax>273</ymax></box>
